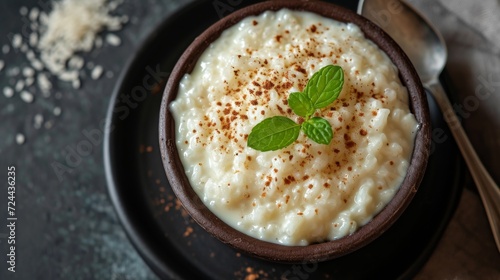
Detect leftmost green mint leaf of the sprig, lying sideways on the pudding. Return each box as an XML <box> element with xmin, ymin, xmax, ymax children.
<box><xmin>247</xmin><ymin>116</ymin><xmax>300</xmax><ymax>152</ymax></box>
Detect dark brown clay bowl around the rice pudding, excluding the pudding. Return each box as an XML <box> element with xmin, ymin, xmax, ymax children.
<box><xmin>159</xmin><ymin>0</ymin><xmax>430</xmax><ymax>263</ymax></box>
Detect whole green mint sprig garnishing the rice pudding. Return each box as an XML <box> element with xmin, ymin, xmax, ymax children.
<box><xmin>247</xmin><ymin>65</ymin><xmax>344</xmax><ymax>152</ymax></box>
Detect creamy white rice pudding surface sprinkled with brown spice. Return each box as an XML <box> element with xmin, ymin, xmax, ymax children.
<box><xmin>170</xmin><ymin>9</ymin><xmax>418</xmax><ymax>245</ymax></box>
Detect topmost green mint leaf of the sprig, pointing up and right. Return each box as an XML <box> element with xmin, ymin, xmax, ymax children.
<box><xmin>304</xmin><ymin>65</ymin><xmax>344</xmax><ymax>109</ymax></box>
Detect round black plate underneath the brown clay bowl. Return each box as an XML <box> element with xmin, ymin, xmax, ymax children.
<box><xmin>104</xmin><ymin>0</ymin><xmax>463</xmax><ymax>279</ymax></box>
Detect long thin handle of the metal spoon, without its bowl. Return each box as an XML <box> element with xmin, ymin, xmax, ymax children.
<box><xmin>427</xmin><ymin>79</ymin><xmax>500</xmax><ymax>251</ymax></box>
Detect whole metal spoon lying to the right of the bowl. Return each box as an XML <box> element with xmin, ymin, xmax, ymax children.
<box><xmin>357</xmin><ymin>0</ymin><xmax>500</xmax><ymax>251</ymax></box>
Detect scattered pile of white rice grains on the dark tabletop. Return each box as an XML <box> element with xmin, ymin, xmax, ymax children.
<box><xmin>0</xmin><ymin>0</ymin><xmax>129</xmax><ymax>140</ymax></box>
